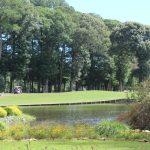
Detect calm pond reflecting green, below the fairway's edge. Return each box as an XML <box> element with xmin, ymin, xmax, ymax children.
<box><xmin>22</xmin><ymin>104</ymin><xmax>129</xmax><ymax>125</ymax></box>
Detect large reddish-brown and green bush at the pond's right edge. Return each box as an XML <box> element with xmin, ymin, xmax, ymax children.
<box><xmin>118</xmin><ymin>80</ymin><xmax>150</xmax><ymax>130</ymax></box>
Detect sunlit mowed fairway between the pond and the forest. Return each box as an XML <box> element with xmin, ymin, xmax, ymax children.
<box><xmin>0</xmin><ymin>91</ymin><xmax>127</xmax><ymax>106</ymax></box>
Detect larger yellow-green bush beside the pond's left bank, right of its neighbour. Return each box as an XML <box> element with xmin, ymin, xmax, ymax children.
<box><xmin>5</xmin><ymin>106</ymin><xmax>22</xmax><ymax>116</ymax></box>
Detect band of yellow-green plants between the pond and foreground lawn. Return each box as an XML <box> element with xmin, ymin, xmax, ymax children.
<box><xmin>0</xmin><ymin>121</ymin><xmax>150</xmax><ymax>141</ymax></box>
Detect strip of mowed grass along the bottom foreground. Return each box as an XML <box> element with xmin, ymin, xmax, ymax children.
<box><xmin>0</xmin><ymin>140</ymin><xmax>150</xmax><ymax>150</ymax></box>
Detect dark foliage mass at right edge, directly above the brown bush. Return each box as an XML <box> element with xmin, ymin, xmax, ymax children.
<box><xmin>110</xmin><ymin>22</ymin><xmax>150</xmax><ymax>89</ymax></box>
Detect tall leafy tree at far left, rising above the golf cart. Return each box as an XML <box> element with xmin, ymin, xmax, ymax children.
<box><xmin>0</xmin><ymin>0</ymin><xmax>36</xmax><ymax>92</ymax></box>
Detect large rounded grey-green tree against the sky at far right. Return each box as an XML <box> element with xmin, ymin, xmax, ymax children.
<box><xmin>110</xmin><ymin>22</ymin><xmax>149</xmax><ymax>90</ymax></box>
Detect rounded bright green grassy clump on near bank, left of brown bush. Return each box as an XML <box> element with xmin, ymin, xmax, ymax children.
<box><xmin>96</xmin><ymin>121</ymin><xmax>129</xmax><ymax>137</ymax></box>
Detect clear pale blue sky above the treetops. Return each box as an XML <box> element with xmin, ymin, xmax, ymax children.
<box><xmin>66</xmin><ymin>0</ymin><xmax>150</xmax><ymax>25</ymax></box>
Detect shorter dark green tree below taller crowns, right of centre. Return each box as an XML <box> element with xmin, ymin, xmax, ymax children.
<box><xmin>87</xmin><ymin>52</ymin><xmax>115</xmax><ymax>90</ymax></box>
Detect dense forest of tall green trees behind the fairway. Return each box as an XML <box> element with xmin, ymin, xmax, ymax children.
<box><xmin>0</xmin><ymin>0</ymin><xmax>150</xmax><ymax>92</ymax></box>
